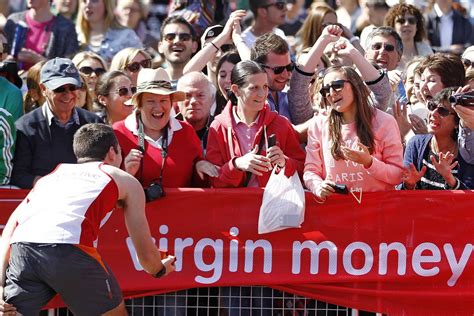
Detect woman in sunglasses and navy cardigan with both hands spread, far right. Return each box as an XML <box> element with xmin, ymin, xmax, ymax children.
<box><xmin>401</xmin><ymin>88</ymin><xmax>474</xmax><ymax>190</ymax></box>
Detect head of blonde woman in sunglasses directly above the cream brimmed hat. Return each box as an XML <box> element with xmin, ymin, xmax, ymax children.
<box><xmin>110</xmin><ymin>47</ymin><xmax>151</xmax><ymax>85</ymax></box>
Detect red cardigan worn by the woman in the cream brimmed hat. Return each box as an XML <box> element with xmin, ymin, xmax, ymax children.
<box><xmin>113</xmin><ymin>113</ymin><xmax>204</xmax><ymax>188</ymax></box>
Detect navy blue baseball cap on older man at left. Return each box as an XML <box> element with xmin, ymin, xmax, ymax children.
<box><xmin>40</xmin><ymin>57</ymin><xmax>82</xmax><ymax>90</ymax></box>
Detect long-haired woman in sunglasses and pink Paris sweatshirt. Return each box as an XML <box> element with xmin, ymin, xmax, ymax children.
<box><xmin>304</xmin><ymin>66</ymin><xmax>403</xmax><ymax>200</ymax></box>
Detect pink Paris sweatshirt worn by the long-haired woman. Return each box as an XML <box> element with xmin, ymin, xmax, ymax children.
<box><xmin>303</xmin><ymin>109</ymin><xmax>403</xmax><ymax>192</ymax></box>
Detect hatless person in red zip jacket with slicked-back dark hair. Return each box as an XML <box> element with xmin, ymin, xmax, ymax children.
<box><xmin>206</xmin><ymin>61</ymin><xmax>305</xmax><ymax>187</ymax></box>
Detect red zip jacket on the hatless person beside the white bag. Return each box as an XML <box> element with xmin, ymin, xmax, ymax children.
<box><xmin>206</xmin><ymin>103</ymin><xmax>305</xmax><ymax>187</ymax></box>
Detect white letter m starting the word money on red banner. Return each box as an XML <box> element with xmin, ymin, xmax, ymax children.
<box><xmin>291</xmin><ymin>240</ymin><xmax>337</xmax><ymax>275</ymax></box>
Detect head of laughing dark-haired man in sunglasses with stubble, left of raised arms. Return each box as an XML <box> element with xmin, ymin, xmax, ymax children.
<box><xmin>158</xmin><ymin>16</ymin><xmax>198</xmax><ymax>90</ymax></box>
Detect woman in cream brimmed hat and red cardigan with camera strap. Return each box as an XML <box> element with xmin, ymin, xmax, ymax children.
<box><xmin>113</xmin><ymin>68</ymin><xmax>213</xmax><ymax>195</ymax></box>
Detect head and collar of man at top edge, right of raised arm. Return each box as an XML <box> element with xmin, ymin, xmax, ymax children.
<box><xmin>242</xmin><ymin>0</ymin><xmax>288</xmax><ymax>48</ymax></box>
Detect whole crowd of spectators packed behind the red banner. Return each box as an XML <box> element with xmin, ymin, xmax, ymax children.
<box><xmin>0</xmin><ymin>0</ymin><xmax>474</xmax><ymax>201</ymax></box>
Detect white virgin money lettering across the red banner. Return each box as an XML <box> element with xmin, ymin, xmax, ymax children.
<box><xmin>126</xmin><ymin>225</ymin><xmax>474</xmax><ymax>287</ymax></box>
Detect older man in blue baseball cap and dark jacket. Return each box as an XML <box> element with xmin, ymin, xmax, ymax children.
<box><xmin>11</xmin><ymin>58</ymin><xmax>102</xmax><ymax>189</ymax></box>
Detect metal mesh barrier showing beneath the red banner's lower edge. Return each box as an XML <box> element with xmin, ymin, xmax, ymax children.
<box><xmin>49</xmin><ymin>286</ymin><xmax>351</xmax><ymax>316</ymax></box>
